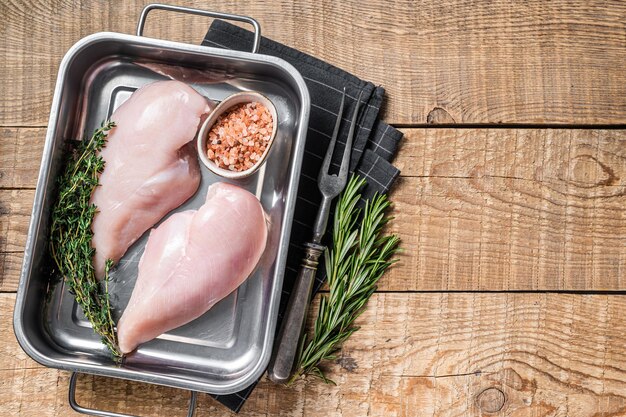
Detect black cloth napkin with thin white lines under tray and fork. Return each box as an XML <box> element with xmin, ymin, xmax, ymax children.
<box><xmin>202</xmin><ymin>20</ymin><xmax>402</xmax><ymax>412</ymax></box>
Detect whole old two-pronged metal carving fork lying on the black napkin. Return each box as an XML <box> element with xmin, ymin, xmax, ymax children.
<box><xmin>268</xmin><ymin>88</ymin><xmax>362</xmax><ymax>383</ymax></box>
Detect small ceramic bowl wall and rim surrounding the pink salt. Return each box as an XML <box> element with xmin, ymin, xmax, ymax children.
<box><xmin>197</xmin><ymin>91</ymin><xmax>278</xmax><ymax>179</ymax></box>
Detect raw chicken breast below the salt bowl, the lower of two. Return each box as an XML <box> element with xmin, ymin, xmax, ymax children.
<box><xmin>117</xmin><ymin>183</ymin><xmax>267</xmax><ymax>353</ymax></box>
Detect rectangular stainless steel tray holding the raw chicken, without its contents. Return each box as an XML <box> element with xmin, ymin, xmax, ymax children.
<box><xmin>14</xmin><ymin>5</ymin><xmax>310</xmax><ymax>400</ymax></box>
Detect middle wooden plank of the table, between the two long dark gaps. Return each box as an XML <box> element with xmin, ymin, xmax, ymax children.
<box><xmin>0</xmin><ymin>129</ymin><xmax>626</xmax><ymax>291</ymax></box>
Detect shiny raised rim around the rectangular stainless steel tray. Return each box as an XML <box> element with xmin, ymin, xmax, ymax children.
<box><xmin>13</xmin><ymin>31</ymin><xmax>311</xmax><ymax>395</ymax></box>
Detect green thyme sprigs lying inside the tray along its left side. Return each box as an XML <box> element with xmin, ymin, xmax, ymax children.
<box><xmin>50</xmin><ymin>122</ymin><xmax>122</xmax><ymax>361</ymax></box>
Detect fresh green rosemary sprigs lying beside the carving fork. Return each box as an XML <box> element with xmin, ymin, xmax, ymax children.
<box><xmin>290</xmin><ymin>176</ymin><xmax>400</xmax><ymax>383</ymax></box>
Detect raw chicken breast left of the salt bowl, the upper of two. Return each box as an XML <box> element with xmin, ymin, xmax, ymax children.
<box><xmin>91</xmin><ymin>81</ymin><xmax>211</xmax><ymax>277</ymax></box>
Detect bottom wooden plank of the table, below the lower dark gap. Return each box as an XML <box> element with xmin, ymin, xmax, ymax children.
<box><xmin>0</xmin><ymin>293</ymin><xmax>626</xmax><ymax>417</ymax></box>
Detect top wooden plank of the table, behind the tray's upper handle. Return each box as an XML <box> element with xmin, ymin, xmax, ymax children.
<box><xmin>0</xmin><ymin>0</ymin><xmax>626</xmax><ymax>126</ymax></box>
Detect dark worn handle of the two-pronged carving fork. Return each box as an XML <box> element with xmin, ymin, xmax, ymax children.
<box><xmin>267</xmin><ymin>243</ymin><xmax>325</xmax><ymax>384</ymax></box>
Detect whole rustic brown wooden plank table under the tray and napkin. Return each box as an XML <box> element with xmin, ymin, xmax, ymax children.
<box><xmin>0</xmin><ymin>0</ymin><xmax>626</xmax><ymax>417</ymax></box>
